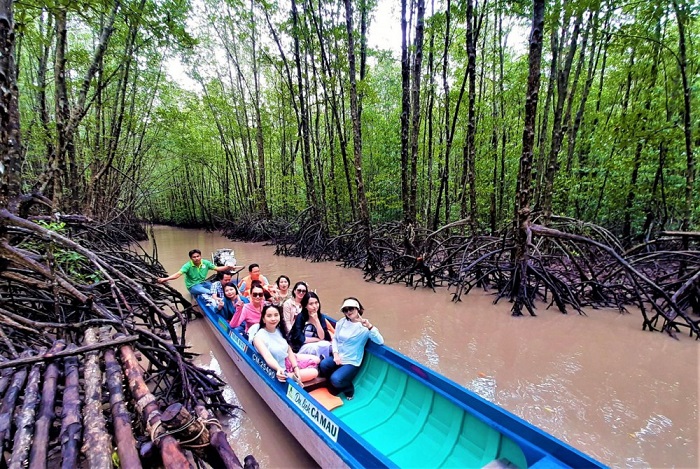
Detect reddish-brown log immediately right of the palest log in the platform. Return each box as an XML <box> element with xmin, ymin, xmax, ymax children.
<box><xmin>105</xmin><ymin>348</ymin><xmax>141</xmax><ymax>468</ymax></box>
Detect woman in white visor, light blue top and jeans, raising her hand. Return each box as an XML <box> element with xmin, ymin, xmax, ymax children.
<box><xmin>319</xmin><ymin>297</ymin><xmax>384</xmax><ymax>400</ymax></box>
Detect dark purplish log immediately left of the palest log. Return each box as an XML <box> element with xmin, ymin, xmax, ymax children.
<box><xmin>60</xmin><ymin>344</ymin><xmax>83</xmax><ymax>469</ymax></box>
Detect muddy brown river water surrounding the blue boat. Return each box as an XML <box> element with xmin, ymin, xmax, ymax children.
<box><xmin>145</xmin><ymin>227</ymin><xmax>700</xmax><ymax>468</ymax></box>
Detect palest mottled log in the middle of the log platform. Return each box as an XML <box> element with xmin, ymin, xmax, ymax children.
<box><xmin>82</xmin><ymin>328</ymin><xmax>112</xmax><ymax>468</ymax></box>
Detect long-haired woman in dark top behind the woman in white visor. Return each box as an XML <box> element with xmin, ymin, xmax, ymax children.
<box><xmin>289</xmin><ymin>292</ymin><xmax>331</xmax><ymax>358</ymax></box>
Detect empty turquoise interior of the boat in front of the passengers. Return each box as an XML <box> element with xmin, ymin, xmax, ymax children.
<box><xmin>333</xmin><ymin>354</ymin><xmax>528</xmax><ymax>467</ymax></box>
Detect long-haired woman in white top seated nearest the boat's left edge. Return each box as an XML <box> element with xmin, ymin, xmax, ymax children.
<box><xmin>253</xmin><ymin>305</ymin><xmax>319</xmax><ymax>382</ymax></box>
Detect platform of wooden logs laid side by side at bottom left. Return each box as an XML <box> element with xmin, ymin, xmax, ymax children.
<box><xmin>0</xmin><ymin>327</ymin><xmax>246</xmax><ymax>468</ymax></box>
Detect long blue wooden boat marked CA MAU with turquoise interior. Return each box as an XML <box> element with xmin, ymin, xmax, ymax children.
<box><xmin>199</xmin><ymin>301</ymin><xmax>604</xmax><ymax>468</ymax></box>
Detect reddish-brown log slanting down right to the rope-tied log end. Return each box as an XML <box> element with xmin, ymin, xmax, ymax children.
<box><xmin>119</xmin><ymin>345</ymin><xmax>191</xmax><ymax>469</ymax></box>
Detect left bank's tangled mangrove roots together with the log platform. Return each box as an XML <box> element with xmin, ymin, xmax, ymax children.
<box><xmin>0</xmin><ymin>196</ymin><xmax>246</xmax><ymax>467</ymax></box>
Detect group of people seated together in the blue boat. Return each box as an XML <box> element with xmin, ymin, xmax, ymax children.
<box><xmin>158</xmin><ymin>249</ymin><xmax>384</xmax><ymax>400</ymax></box>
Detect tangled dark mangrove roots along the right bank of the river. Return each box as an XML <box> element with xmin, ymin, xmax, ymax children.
<box><xmin>224</xmin><ymin>210</ymin><xmax>700</xmax><ymax>338</ymax></box>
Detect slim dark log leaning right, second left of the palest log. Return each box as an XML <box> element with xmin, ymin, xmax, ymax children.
<box><xmin>29</xmin><ymin>340</ymin><xmax>66</xmax><ymax>469</ymax></box>
